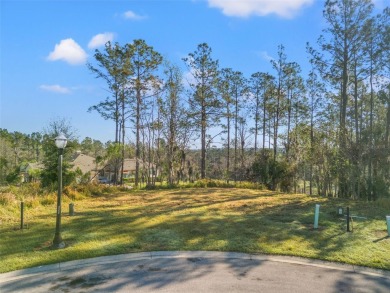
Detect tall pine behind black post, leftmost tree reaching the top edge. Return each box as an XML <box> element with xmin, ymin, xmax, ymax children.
<box><xmin>309</xmin><ymin>0</ymin><xmax>373</xmax><ymax>197</ymax></box>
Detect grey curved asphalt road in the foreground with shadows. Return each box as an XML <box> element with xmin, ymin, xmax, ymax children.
<box><xmin>0</xmin><ymin>252</ymin><xmax>390</xmax><ymax>293</ymax></box>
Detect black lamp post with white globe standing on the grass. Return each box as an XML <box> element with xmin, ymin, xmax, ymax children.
<box><xmin>53</xmin><ymin>133</ymin><xmax>67</xmax><ymax>248</ymax></box>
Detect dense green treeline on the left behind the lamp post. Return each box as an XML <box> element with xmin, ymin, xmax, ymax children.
<box><xmin>0</xmin><ymin>119</ymin><xmax>105</xmax><ymax>187</ymax></box>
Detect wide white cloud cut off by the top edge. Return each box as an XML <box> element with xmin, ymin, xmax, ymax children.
<box><xmin>208</xmin><ymin>0</ymin><xmax>314</xmax><ymax>18</ymax></box>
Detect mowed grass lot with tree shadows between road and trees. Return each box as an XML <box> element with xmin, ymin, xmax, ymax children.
<box><xmin>0</xmin><ymin>188</ymin><xmax>390</xmax><ymax>272</ymax></box>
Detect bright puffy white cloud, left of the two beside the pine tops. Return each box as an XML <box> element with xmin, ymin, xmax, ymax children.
<box><xmin>47</xmin><ymin>39</ymin><xmax>88</xmax><ymax>65</ymax></box>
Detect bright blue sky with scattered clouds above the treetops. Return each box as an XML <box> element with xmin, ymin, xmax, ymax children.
<box><xmin>0</xmin><ymin>0</ymin><xmax>389</xmax><ymax>142</ymax></box>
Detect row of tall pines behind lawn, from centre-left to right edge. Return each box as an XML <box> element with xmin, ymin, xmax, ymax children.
<box><xmin>0</xmin><ymin>0</ymin><xmax>390</xmax><ymax>200</ymax></box>
